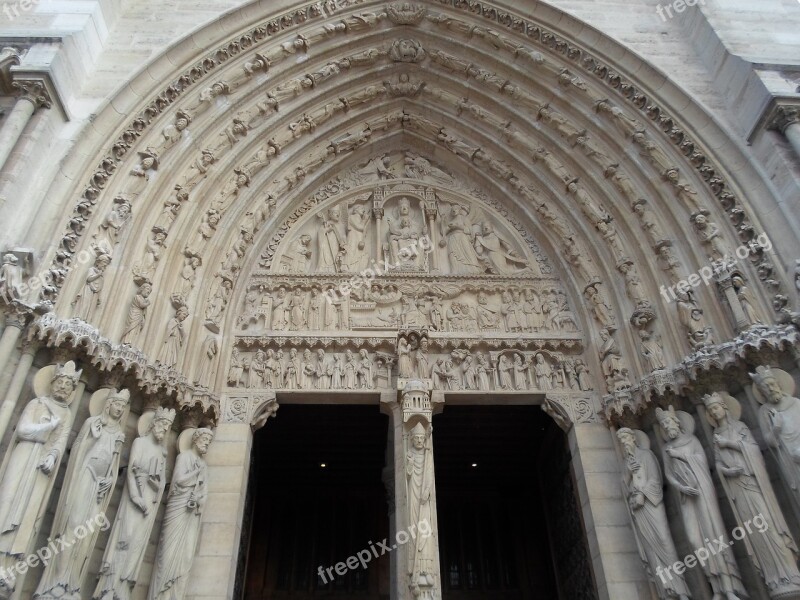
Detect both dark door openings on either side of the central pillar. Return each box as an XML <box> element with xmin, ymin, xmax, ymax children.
<box><xmin>239</xmin><ymin>404</ymin><xmax>596</xmax><ymax>600</ymax></box>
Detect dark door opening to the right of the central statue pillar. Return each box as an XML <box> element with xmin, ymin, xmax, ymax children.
<box><xmin>433</xmin><ymin>406</ymin><xmax>595</xmax><ymax>600</ymax></box>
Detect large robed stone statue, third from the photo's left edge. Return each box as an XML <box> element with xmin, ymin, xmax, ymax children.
<box><xmin>92</xmin><ymin>408</ymin><xmax>175</xmax><ymax>600</ymax></box>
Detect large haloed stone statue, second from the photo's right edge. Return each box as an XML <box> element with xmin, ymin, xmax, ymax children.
<box><xmin>703</xmin><ymin>392</ymin><xmax>800</xmax><ymax>598</ymax></box>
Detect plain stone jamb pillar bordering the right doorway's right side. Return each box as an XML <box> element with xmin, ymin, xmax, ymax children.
<box><xmin>543</xmin><ymin>394</ymin><xmax>656</xmax><ymax>600</ymax></box>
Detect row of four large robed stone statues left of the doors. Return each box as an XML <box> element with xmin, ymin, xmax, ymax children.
<box><xmin>0</xmin><ymin>362</ymin><xmax>213</xmax><ymax>600</ymax></box>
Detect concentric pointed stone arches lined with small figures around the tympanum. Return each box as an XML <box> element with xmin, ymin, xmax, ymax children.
<box><xmin>37</xmin><ymin>0</ymin><xmax>788</xmax><ymax>404</ymax></box>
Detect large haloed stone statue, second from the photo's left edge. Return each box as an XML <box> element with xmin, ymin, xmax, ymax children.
<box><xmin>33</xmin><ymin>389</ymin><xmax>131</xmax><ymax>600</ymax></box>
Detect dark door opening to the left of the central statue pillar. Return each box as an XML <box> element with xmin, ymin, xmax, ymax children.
<box><xmin>244</xmin><ymin>405</ymin><xmax>389</xmax><ymax>600</ymax></box>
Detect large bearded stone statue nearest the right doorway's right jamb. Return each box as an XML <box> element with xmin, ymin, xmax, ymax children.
<box><xmin>617</xmin><ymin>427</ymin><xmax>689</xmax><ymax>600</ymax></box>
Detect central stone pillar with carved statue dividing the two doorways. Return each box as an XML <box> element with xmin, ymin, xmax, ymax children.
<box><xmin>381</xmin><ymin>380</ymin><xmax>443</xmax><ymax>600</ymax></box>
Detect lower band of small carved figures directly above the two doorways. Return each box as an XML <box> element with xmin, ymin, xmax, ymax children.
<box><xmin>228</xmin><ymin>339</ymin><xmax>592</xmax><ymax>391</ymax></box>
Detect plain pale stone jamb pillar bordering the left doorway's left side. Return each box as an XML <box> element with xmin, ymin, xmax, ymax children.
<box><xmin>185</xmin><ymin>392</ymin><xmax>278</xmax><ymax>599</ymax></box>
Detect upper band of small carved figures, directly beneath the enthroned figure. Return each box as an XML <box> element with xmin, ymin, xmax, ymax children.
<box><xmin>238</xmin><ymin>285</ymin><xmax>578</xmax><ymax>333</ymax></box>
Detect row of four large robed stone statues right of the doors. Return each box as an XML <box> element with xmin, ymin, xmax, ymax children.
<box><xmin>617</xmin><ymin>367</ymin><xmax>800</xmax><ymax>600</ymax></box>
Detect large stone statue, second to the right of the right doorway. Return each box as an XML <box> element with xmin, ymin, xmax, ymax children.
<box><xmin>656</xmin><ymin>406</ymin><xmax>747</xmax><ymax>600</ymax></box>
